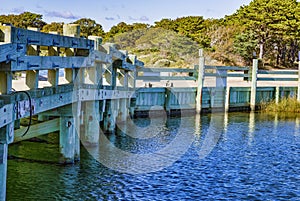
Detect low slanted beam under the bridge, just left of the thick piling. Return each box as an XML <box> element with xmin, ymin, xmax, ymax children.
<box><xmin>14</xmin><ymin>118</ymin><xmax>60</xmax><ymax>142</ymax></box>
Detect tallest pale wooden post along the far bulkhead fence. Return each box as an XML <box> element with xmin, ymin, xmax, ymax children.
<box><xmin>196</xmin><ymin>49</ymin><xmax>205</xmax><ymax>114</ymax></box>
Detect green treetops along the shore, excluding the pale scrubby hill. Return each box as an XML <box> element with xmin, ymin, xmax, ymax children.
<box><xmin>0</xmin><ymin>0</ymin><xmax>300</xmax><ymax>67</ymax></box>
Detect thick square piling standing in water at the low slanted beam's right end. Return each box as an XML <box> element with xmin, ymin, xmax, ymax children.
<box><xmin>59</xmin><ymin>116</ymin><xmax>76</xmax><ymax>163</ymax></box>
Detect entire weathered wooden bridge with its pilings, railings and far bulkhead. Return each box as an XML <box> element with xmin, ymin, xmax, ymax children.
<box><xmin>0</xmin><ymin>25</ymin><xmax>300</xmax><ymax>200</ymax></box>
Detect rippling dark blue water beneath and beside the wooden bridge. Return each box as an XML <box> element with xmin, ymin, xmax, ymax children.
<box><xmin>7</xmin><ymin>113</ymin><xmax>300</xmax><ymax>200</ymax></box>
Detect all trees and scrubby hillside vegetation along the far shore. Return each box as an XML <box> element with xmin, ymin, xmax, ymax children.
<box><xmin>0</xmin><ymin>0</ymin><xmax>300</xmax><ymax>68</ymax></box>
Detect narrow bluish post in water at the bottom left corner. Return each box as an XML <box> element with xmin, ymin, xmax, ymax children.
<box><xmin>0</xmin><ymin>143</ymin><xmax>8</xmax><ymax>201</ymax></box>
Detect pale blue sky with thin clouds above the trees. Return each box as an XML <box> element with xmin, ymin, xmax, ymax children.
<box><xmin>0</xmin><ymin>0</ymin><xmax>251</xmax><ymax>31</ymax></box>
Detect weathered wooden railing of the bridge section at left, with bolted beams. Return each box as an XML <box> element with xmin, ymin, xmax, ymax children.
<box><xmin>0</xmin><ymin>25</ymin><xmax>143</xmax><ymax>141</ymax></box>
